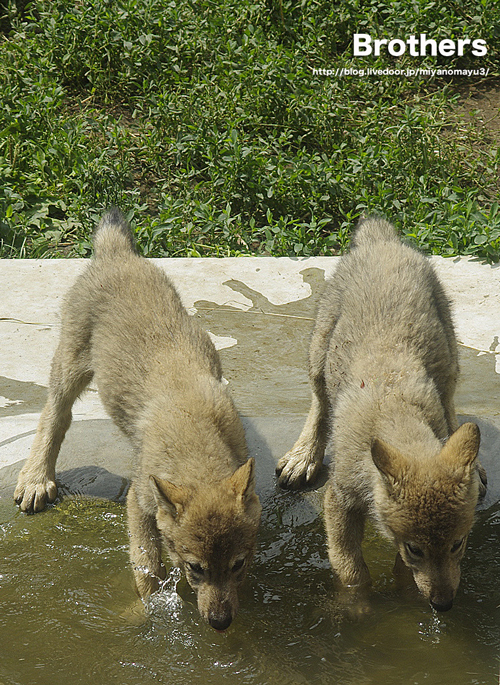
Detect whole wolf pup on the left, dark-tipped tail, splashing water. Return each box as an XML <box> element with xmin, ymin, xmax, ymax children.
<box><xmin>14</xmin><ymin>210</ymin><xmax>261</xmax><ymax>630</ymax></box>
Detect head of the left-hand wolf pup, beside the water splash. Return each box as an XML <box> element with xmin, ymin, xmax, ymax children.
<box><xmin>151</xmin><ymin>459</ymin><xmax>261</xmax><ymax>631</ymax></box>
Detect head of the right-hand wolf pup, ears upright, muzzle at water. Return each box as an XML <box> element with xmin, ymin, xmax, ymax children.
<box><xmin>371</xmin><ymin>423</ymin><xmax>480</xmax><ymax>611</ymax></box>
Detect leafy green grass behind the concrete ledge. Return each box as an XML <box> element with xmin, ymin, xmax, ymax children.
<box><xmin>0</xmin><ymin>0</ymin><xmax>500</xmax><ymax>261</ymax></box>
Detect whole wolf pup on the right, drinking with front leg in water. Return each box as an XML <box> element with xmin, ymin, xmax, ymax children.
<box><xmin>277</xmin><ymin>218</ymin><xmax>486</xmax><ymax>611</ymax></box>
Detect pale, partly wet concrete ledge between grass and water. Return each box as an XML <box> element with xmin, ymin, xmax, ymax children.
<box><xmin>0</xmin><ymin>257</ymin><xmax>500</xmax><ymax>507</ymax></box>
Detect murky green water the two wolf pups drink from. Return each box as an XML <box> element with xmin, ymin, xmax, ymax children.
<box><xmin>0</xmin><ymin>492</ymin><xmax>500</xmax><ymax>685</ymax></box>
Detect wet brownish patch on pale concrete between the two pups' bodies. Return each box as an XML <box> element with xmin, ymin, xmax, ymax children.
<box><xmin>195</xmin><ymin>268</ymin><xmax>324</xmax><ymax>416</ymax></box>
